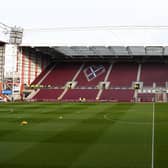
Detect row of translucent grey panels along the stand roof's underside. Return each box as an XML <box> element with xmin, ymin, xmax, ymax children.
<box><xmin>54</xmin><ymin>46</ymin><xmax>168</xmax><ymax>56</ymax></box>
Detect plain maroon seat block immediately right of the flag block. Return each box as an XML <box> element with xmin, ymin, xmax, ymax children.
<box><xmin>99</xmin><ymin>63</ymin><xmax>140</xmax><ymax>102</ymax></box>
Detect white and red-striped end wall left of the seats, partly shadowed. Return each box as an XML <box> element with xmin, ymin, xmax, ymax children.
<box><xmin>16</xmin><ymin>47</ymin><xmax>51</xmax><ymax>85</ymax></box>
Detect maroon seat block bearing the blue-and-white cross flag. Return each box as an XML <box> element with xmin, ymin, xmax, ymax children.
<box><xmin>61</xmin><ymin>63</ymin><xmax>110</xmax><ymax>101</ymax></box>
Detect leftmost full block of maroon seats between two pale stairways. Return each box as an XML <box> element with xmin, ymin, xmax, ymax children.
<box><xmin>30</xmin><ymin>63</ymin><xmax>83</xmax><ymax>100</ymax></box>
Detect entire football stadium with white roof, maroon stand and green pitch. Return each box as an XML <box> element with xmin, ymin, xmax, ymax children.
<box><xmin>0</xmin><ymin>18</ymin><xmax>168</xmax><ymax>168</ymax></box>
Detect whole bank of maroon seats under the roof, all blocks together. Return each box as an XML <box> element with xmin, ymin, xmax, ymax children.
<box><xmin>28</xmin><ymin>62</ymin><xmax>168</xmax><ymax>102</ymax></box>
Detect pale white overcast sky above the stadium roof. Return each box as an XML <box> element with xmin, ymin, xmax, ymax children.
<box><xmin>0</xmin><ymin>0</ymin><xmax>168</xmax><ymax>28</ymax></box>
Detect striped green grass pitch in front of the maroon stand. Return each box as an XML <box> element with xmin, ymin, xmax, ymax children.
<box><xmin>0</xmin><ymin>103</ymin><xmax>168</xmax><ymax>168</ymax></box>
